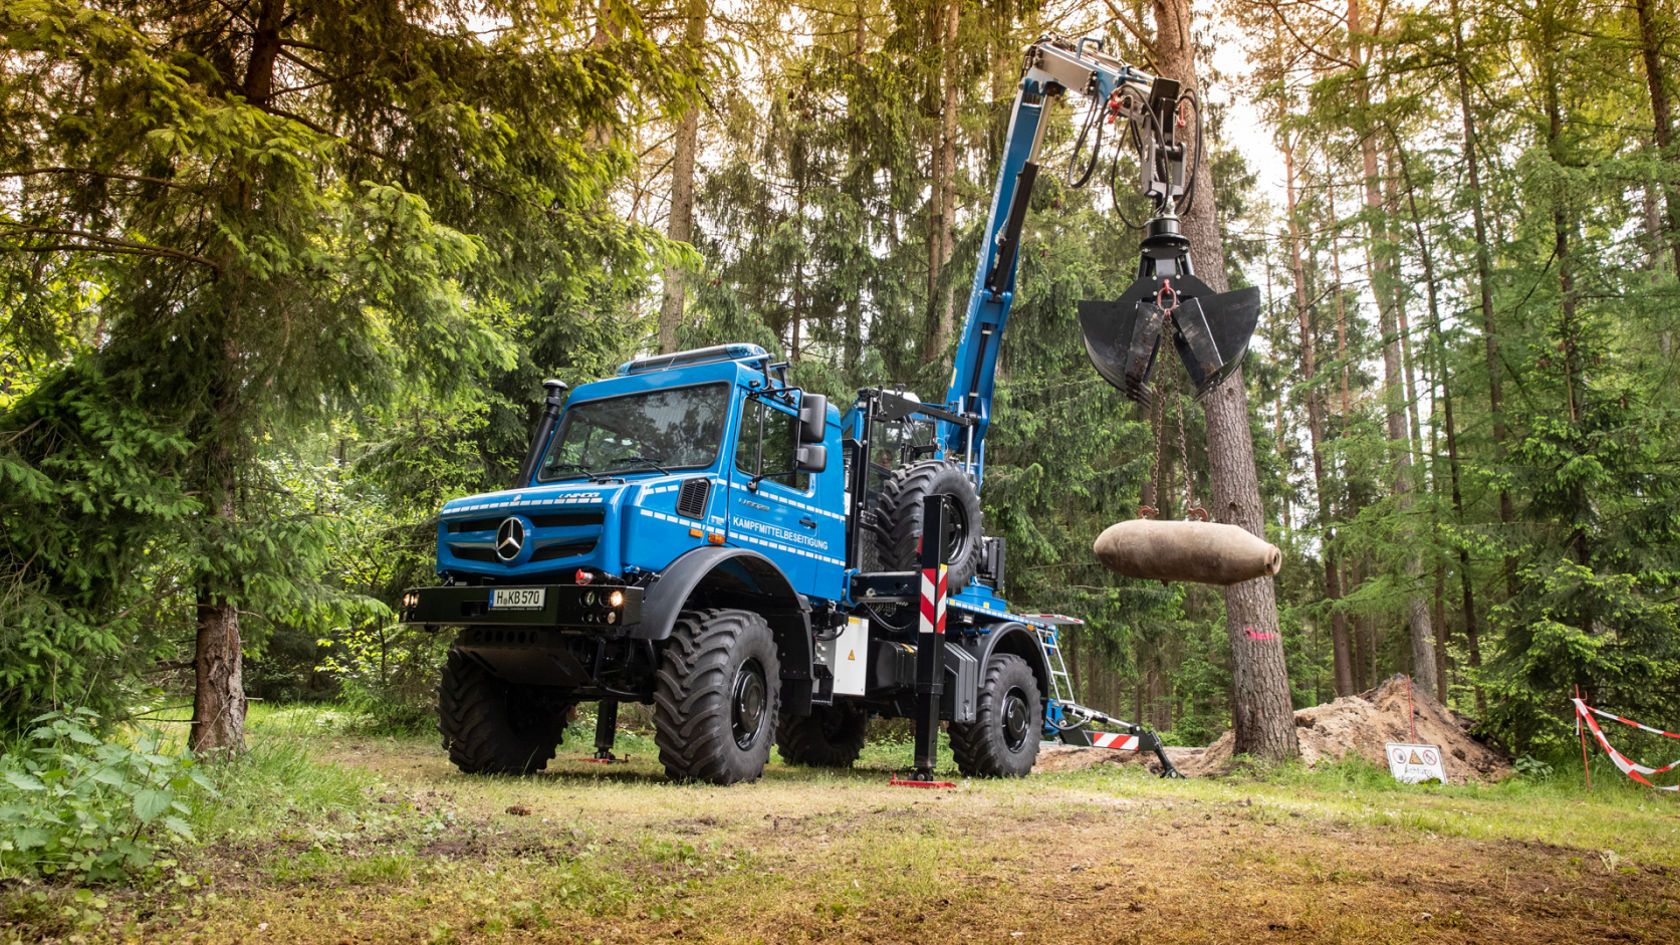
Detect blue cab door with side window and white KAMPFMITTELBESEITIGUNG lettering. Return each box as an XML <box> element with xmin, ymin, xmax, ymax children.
<box><xmin>729</xmin><ymin>397</ymin><xmax>823</xmax><ymax>594</ymax></box>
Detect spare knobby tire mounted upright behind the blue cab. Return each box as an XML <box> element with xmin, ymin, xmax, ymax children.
<box><xmin>875</xmin><ymin>459</ymin><xmax>981</xmax><ymax>594</ymax></box>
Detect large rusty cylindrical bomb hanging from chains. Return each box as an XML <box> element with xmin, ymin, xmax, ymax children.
<box><xmin>1095</xmin><ymin>518</ymin><xmax>1284</xmax><ymax>583</ymax></box>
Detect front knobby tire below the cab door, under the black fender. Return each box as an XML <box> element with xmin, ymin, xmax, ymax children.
<box><xmin>654</xmin><ymin>610</ymin><xmax>781</xmax><ymax>784</ymax></box>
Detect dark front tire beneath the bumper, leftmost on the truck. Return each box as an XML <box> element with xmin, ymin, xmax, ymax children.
<box><xmin>437</xmin><ymin>649</ymin><xmax>573</xmax><ymax>775</ymax></box>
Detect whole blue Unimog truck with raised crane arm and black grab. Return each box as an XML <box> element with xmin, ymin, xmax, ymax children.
<box><xmin>402</xmin><ymin>39</ymin><xmax>1258</xmax><ymax>784</ymax></box>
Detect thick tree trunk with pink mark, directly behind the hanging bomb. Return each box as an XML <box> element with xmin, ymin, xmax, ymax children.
<box><xmin>1154</xmin><ymin>0</ymin><xmax>1299</xmax><ymax>758</ymax></box>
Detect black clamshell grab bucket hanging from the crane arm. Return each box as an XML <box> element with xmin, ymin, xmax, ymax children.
<box><xmin>1079</xmin><ymin>215</ymin><xmax>1260</xmax><ymax>404</ymax></box>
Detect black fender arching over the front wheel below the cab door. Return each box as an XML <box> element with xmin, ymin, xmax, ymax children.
<box><xmin>627</xmin><ymin>546</ymin><xmax>815</xmax><ymax>715</ymax></box>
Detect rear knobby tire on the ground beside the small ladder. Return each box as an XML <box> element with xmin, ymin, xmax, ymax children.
<box><xmin>949</xmin><ymin>652</ymin><xmax>1045</xmax><ymax>777</ymax></box>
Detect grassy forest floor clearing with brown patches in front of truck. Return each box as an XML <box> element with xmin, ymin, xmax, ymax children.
<box><xmin>0</xmin><ymin>715</ymin><xmax>1680</xmax><ymax>945</ymax></box>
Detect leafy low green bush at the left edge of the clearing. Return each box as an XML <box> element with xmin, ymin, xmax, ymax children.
<box><xmin>0</xmin><ymin>708</ymin><xmax>213</xmax><ymax>883</ymax></box>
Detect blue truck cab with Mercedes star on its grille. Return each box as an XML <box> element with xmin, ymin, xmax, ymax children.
<box><xmin>437</xmin><ymin>345</ymin><xmax>847</xmax><ymax>598</ymax></box>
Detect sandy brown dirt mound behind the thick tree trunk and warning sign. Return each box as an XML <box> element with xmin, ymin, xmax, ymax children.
<box><xmin>1033</xmin><ymin>674</ymin><xmax>1510</xmax><ymax>784</ymax></box>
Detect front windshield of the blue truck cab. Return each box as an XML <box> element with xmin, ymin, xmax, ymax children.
<box><xmin>538</xmin><ymin>383</ymin><xmax>729</xmax><ymax>481</ymax></box>
